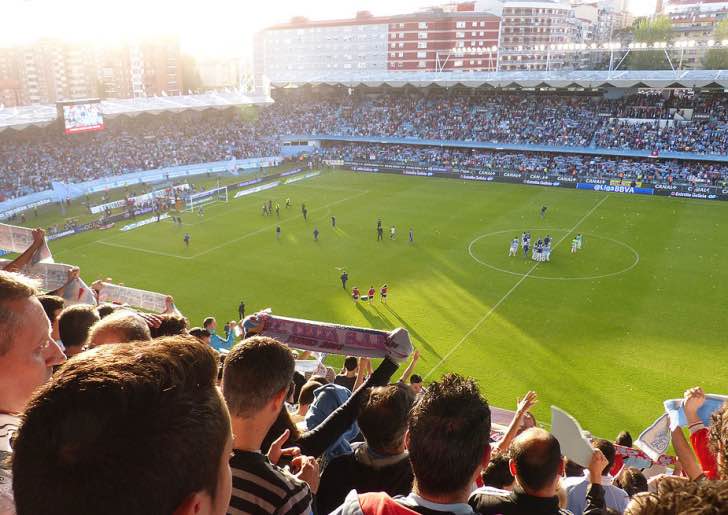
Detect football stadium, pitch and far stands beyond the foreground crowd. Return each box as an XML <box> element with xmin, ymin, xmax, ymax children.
<box><xmin>0</xmin><ymin>62</ymin><xmax>728</xmax><ymax>513</ymax></box>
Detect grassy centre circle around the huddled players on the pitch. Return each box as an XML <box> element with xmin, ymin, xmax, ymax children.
<box><xmin>468</xmin><ymin>228</ymin><xmax>640</xmax><ymax>281</ymax></box>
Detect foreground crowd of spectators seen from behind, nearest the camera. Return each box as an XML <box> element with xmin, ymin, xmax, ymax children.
<box><xmin>0</xmin><ymin>230</ymin><xmax>728</xmax><ymax>515</ymax></box>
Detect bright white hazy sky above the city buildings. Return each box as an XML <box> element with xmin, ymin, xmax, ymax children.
<box><xmin>0</xmin><ymin>0</ymin><xmax>655</xmax><ymax>58</ymax></box>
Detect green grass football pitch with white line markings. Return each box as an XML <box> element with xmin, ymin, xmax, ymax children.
<box><xmin>51</xmin><ymin>171</ymin><xmax>728</xmax><ymax>437</ymax></box>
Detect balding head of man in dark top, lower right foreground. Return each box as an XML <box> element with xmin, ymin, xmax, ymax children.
<box><xmin>509</xmin><ymin>428</ymin><xmax>564</xmax><ymax>497</ymax></box>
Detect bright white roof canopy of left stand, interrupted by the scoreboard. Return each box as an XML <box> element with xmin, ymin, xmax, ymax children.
<box><xmin>0</xmin><ymin>91</ymin><xmax>272</xmax><ymax>131</ymax></box>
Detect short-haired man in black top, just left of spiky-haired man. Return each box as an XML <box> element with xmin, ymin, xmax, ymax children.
<box><xmin>316</xmin><ymin>383</ymin><xmax>414</xmax><ymax>513</ymax></box>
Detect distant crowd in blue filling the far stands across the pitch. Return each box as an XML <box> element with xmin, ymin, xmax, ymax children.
<box><xmin>0</xmin><ymin>88</ymin><xmax>728</xmax><ymax>200</ymax></box>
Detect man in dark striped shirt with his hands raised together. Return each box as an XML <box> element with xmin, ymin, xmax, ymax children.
<box><xmin>222</xmin><ymin>336</ymin><xmax>319</xmax><ymax>515</ymax></box>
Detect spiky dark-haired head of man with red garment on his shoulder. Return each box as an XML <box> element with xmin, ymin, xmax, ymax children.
<box><xmin>405</xmin><ymin>374</ymin><xmax>490</xmax><ymax>499</ymax></box>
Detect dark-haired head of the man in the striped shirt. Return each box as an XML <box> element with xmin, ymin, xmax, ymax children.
<box><xmin>222</xmin><ymin>336</ymin><xmax>295</xmax><ymax>436</ymax></box>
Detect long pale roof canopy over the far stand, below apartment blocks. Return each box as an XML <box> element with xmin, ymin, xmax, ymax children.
<box><xmin>271</xmin><ymin>70</ymin><xmax>728</xmax><ymax>89</ymax></box>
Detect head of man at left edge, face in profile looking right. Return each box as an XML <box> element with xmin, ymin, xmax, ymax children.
<box><xmin>0</xmin><ymin>270</ymin><xmax>66</xmax><ymax>413</ymax></box>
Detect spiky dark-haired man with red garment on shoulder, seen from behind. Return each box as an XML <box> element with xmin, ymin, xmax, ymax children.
<box><xmin>333</xmin><ymin>374</ymin><xmax>490</xmax><ymax>515</ymax></box>
